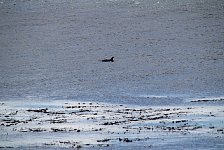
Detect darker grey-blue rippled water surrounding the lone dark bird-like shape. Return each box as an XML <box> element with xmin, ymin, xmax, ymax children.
<box><xmin>0</xmin><ymin>0</ymin><xmax>224</xmax><ymax>105</ymax></box>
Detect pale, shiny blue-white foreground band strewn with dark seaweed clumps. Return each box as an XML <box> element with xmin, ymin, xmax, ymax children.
<box><xmin>0</xmin><ymin>101</ymin><xmax>224</xmax><ymax>149</ymax></box>
